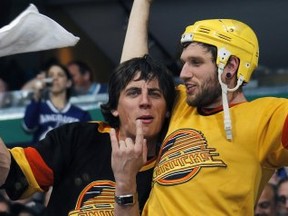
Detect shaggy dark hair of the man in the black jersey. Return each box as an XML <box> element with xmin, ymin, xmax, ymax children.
<box><xmin>100</xmin><ymin>55</ymin><xmax>176</xmax><ymax>128</ymax></box>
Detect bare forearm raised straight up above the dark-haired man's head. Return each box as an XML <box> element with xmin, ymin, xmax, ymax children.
<box><xmin>120</xmin><ymin>0</ymin><xmax>152</xmax><ymax>62</ymax></box>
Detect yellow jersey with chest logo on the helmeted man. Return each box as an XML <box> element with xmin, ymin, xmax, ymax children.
<box><xmin>142</xmin><ymin>85</ymin><xmax>288</xmax><ymax>216</ymax></box>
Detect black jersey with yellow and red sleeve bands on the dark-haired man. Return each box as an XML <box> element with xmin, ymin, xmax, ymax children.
<box><xmin>4</xmin><ymin>122</ymin><xmax>155</xmax><ymax>216</ymax></box>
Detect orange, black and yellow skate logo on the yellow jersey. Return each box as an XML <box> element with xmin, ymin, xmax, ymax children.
<box><xmin>153</xmin><ymin>129</ymin><xmax>226</xmax><ymax>185</ymax></box>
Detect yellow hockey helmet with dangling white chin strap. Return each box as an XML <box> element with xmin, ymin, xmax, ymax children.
<box><xmin>181</xmin><ymin>19</ymin><xmax>259</xmax><ymax>140</ymax></box>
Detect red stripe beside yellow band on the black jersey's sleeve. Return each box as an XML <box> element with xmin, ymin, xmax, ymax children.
<box><xmin>24</xmin><ymin>147</ymin><xmax>54</xmax><ymax>191</ymax></box>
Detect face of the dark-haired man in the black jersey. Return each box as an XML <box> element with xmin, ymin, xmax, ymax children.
<box><xmin>112</xmin><ymin>73</ymin><xmax>167</xmax><ymax>139</ymax></box>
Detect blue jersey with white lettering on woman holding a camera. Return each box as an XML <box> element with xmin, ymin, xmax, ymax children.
<box><xmin>23</xmin><ymin>100</ymin><xmax>91</xmax><ymax>144</ymax></box>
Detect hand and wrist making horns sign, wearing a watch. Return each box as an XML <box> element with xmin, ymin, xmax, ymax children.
<box><xmin>110</xmin><ymin>120</ymin><xmax>147</xmax><ymax>216</ymax></box>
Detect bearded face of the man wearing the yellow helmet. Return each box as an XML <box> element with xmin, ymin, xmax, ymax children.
<box><xmin>180</xmin><ymin>43</ymin><xmax>221</xmax><ymax>107</ymax></box>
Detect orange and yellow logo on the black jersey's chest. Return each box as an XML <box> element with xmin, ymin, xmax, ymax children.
<box><xmin>69</xmin><ymin>181</ymin><xmax>115</xmax><ymax>216</ymax></box>
